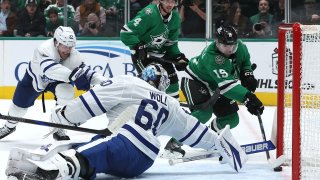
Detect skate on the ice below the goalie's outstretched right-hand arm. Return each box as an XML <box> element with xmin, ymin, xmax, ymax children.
<box><xmin>161</xmin><ymin>138</ymin><xmax>186</xmax><ymax>159</ymax></box>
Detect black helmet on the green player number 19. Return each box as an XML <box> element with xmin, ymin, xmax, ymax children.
<box><xmin>216</xmin><ymin>26</ymin><xmax>238</xmax><ymax>45</ymax></box>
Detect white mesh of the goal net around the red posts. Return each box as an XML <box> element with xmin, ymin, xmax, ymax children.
<box><xmin>284</xmin><ymin>25</ymin><xmax>320</xmax><ymax>179</ymax></box>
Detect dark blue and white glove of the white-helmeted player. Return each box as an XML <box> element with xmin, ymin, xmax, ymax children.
<box><xmin>69</xmin><ymin>63</ymin><xmax>90</xmax><ymax>91</ymax></box>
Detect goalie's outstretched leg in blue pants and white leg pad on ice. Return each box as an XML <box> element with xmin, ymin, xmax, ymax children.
<box><xmin>6</xmin><ymin>134</ymin><xmax>154</xmax><ymax>179</ymax></box>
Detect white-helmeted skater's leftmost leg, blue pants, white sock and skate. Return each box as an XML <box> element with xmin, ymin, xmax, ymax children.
<box><xmin>0</xmin><ymin>72</ymin><xmax>40</xmax><ymax>139</ymax></box>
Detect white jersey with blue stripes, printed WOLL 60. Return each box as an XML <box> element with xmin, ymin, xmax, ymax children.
<box><xmin>64</xmin><ymin>75</ymin><xmax>217</xmax><ymax>159</ymax></box>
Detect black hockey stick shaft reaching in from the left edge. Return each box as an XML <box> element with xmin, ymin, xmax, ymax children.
<box><xmin>0</xmin><ymin>114</ymin><xmax>112</xmax><ymax>136</ymax></box>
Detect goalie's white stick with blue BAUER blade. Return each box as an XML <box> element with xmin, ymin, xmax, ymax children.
<box><xmin>169</xmin><ymin>140</ymin><xmax>276</xmax><ymax>166</ymax></box>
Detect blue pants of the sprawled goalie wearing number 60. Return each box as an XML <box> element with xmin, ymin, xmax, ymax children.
<box><xmin>77</xmin><ymin>134</ymin><xmax>154</xmax><ymax>178</ymax></box>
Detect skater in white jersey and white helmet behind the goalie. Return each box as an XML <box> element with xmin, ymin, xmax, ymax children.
<box><xmin>0</xmin><ymin>26</ymin><xmax>106</xmax><ymax>140</ymax></box>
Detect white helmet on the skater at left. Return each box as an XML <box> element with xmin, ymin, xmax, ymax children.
<box><xmin>53</xmin><ymin>26</ymin><xmax>77</xmax><ymax>47</ymax></box>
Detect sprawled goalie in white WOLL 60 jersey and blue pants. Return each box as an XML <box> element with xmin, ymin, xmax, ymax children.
<box><xmin>6</xmin><ymin>64</ymin><xmax>247</xmax><ymax>180</ymax></box>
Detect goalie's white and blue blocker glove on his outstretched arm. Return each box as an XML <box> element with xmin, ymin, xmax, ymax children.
<box><xmin>215</xmin><ymin>125</ymin><xmax>248</xmax><ymax>172</ymax></box>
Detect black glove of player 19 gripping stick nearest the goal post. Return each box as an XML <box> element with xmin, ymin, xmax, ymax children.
<box><xmin>244</xmin><ymin>92</ymin><xmax>264</xmax><ymax>115</ymax></box>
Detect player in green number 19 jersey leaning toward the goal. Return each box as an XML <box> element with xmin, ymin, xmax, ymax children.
<box><xmin>181</xmin><ymin>26</ymin><xmax>264</xmax><ymax>131</ymax></box>
